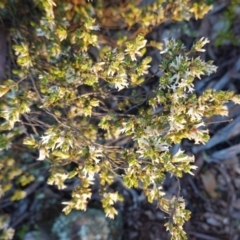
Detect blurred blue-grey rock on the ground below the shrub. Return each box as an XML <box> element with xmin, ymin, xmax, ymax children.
<box><xmin>52</xmin><ymin>208</ymin><xmax>122</xmax><ymax>240</ymax></box>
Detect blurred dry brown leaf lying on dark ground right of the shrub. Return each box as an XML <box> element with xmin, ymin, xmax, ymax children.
<box><xmin>201</xmin><ymin>171</ymin><xmax>217</xmax><ymax>198</ymax></box>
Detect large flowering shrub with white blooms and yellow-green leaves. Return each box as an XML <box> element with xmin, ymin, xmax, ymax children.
<box><xmin>0</xmin><ymin>0</ymin><xmax>239</xmax><ymax>239</ymax></box>
